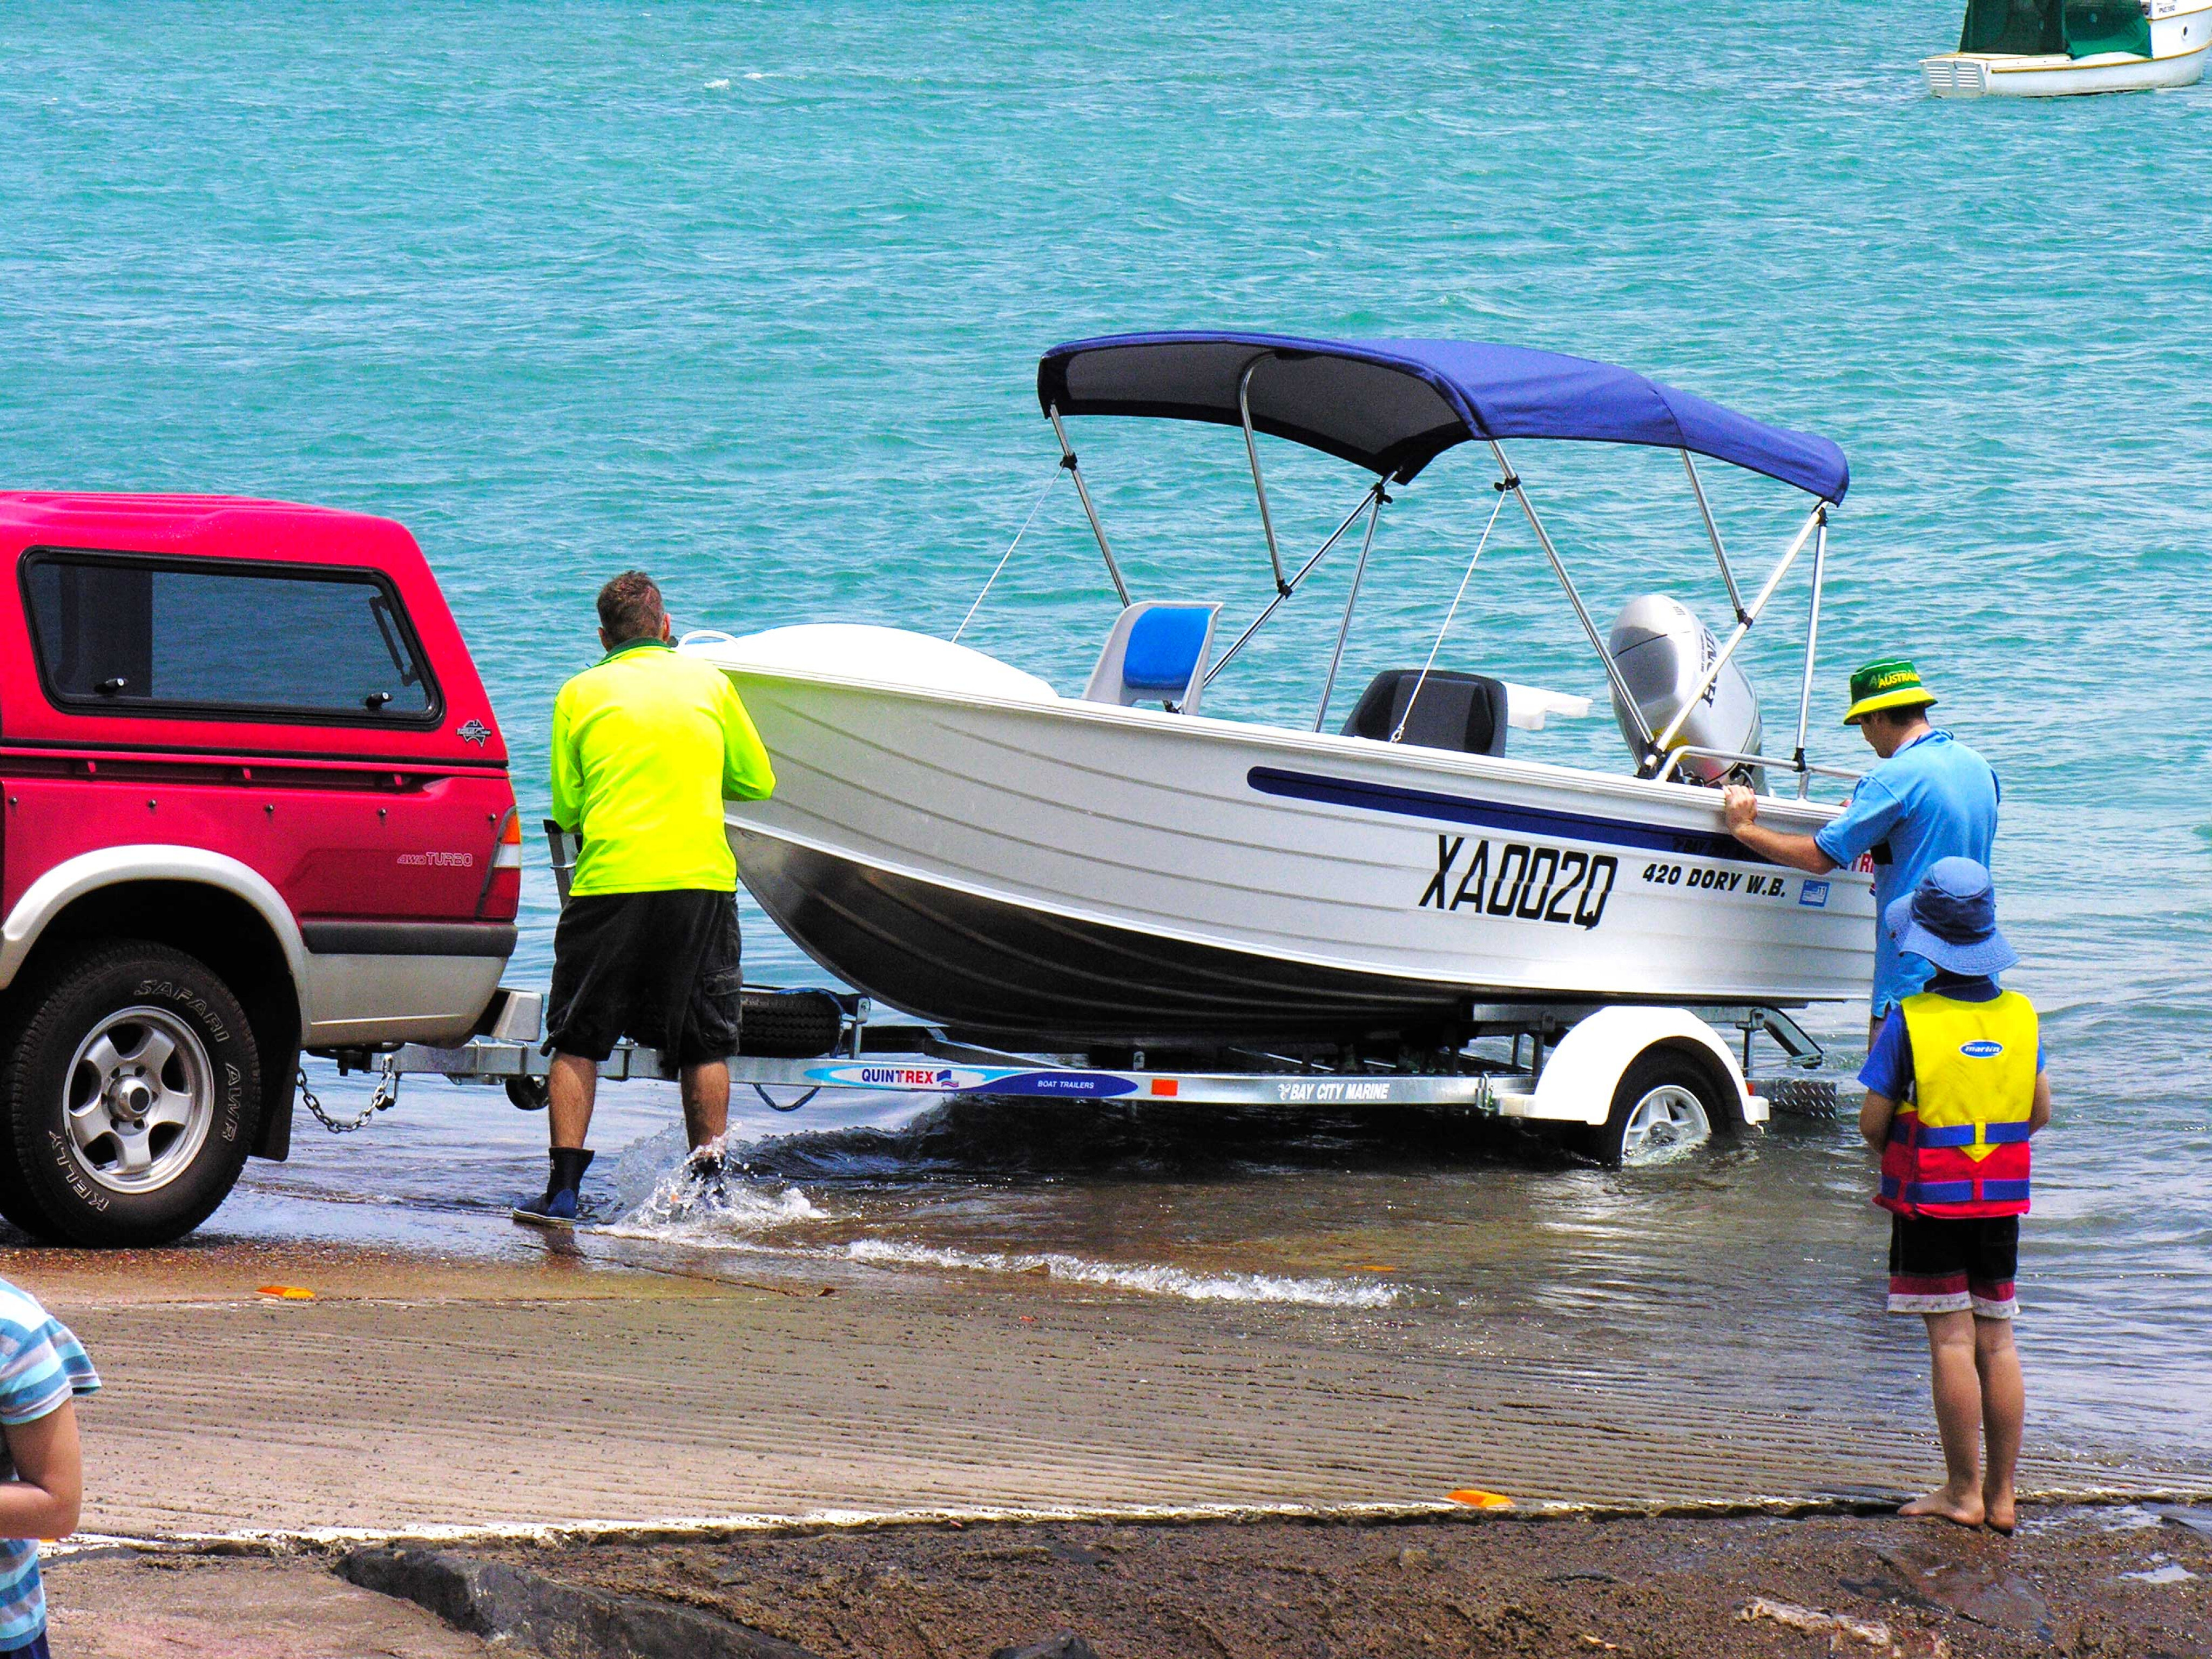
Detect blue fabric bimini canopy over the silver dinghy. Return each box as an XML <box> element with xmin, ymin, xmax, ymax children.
<box><xmin>1037</xmin><ymin>332</ymin><xmax>1851</xmax><ymax>502</ymax></box>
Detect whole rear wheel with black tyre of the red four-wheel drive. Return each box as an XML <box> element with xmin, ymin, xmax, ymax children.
<box><xmin>0</xmin><ymin>940</ymin><xmax>261</xmax><ymax>1247</ymax></box>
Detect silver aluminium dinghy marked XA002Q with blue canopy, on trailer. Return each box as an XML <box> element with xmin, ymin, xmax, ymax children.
<box><xmin>686</xmin><ymin>334</ymin><xmax>1873</xmax><ymax>1046</ymax></box>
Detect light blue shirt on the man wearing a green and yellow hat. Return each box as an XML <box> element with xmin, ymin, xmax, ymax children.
<box><xmin>1814</xmin><ymin>732</ymin><xmax>1998</xmax><ymax>1020</ymax></box>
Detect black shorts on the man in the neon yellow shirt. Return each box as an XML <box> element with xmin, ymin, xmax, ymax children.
<box><xmin>547</xmin><ymin>887</ymin><xmax>745</xmax><ymax>1066</ymax></box>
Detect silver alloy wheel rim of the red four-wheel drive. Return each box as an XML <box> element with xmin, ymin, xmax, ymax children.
<box><xmin>62</xmin><ymin>1009</ymin><xmax>214</xmax><ymax>1192</ymax></box>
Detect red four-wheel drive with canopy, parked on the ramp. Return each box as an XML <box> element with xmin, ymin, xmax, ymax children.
<box><xmin>0</xmin><ymin>493</ymin><xmax>522</xmax><ymax>1245</ymax></box>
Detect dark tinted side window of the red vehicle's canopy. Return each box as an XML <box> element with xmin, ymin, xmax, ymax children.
<box><xmin>24</xmin><ymin>553</ymin><xmax>436</xmax><ymax>721</ymax></box>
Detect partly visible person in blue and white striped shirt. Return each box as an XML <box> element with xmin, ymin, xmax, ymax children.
<box><xmin>0</xmin><ymin>1278</ymin><xmax>99</xmax><ymax>1659</ymax></box>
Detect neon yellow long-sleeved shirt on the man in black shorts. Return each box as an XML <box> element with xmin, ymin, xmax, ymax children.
<box><xmin>553</xmin><ymin>639</ymin><xmax>777</xmax><ymax>898</ymax></box>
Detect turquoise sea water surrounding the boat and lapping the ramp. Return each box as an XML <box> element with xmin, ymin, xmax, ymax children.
<box><xmin>0</xmin><ymin>0</ymin><xmax>2212</xmax><ymax>1467</ymax></box>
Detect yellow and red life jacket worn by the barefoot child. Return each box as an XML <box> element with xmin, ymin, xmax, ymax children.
<box><xmin>1876</xmin><ymin>991</ymin><xmax>2037</xmax><ymax>1217</ymax></box>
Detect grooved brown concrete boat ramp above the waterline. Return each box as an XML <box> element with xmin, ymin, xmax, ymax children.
<box><xmin>13</xmin><ymin>1239</ymin><xmax>2212</xmax><ymax>1540</ymax></box>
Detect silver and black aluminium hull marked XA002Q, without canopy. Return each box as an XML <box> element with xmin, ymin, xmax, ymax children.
<box><xmin>708</xmin><ymin>652</ymin><xmax>1873</xmax><ymax>1040</ymax></box>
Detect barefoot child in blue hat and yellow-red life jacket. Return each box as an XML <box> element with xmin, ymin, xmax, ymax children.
<box><xmin>1858</xmin><ymin>858</ymin><xmax>2051</xmax><ymax>1533</ymax></box>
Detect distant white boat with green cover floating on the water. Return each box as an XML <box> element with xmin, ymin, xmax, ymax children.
<box><xmin>1920</xmin><ymin>0</ymin><xmax>2212</xmax><ymax>97</ymax></box>
